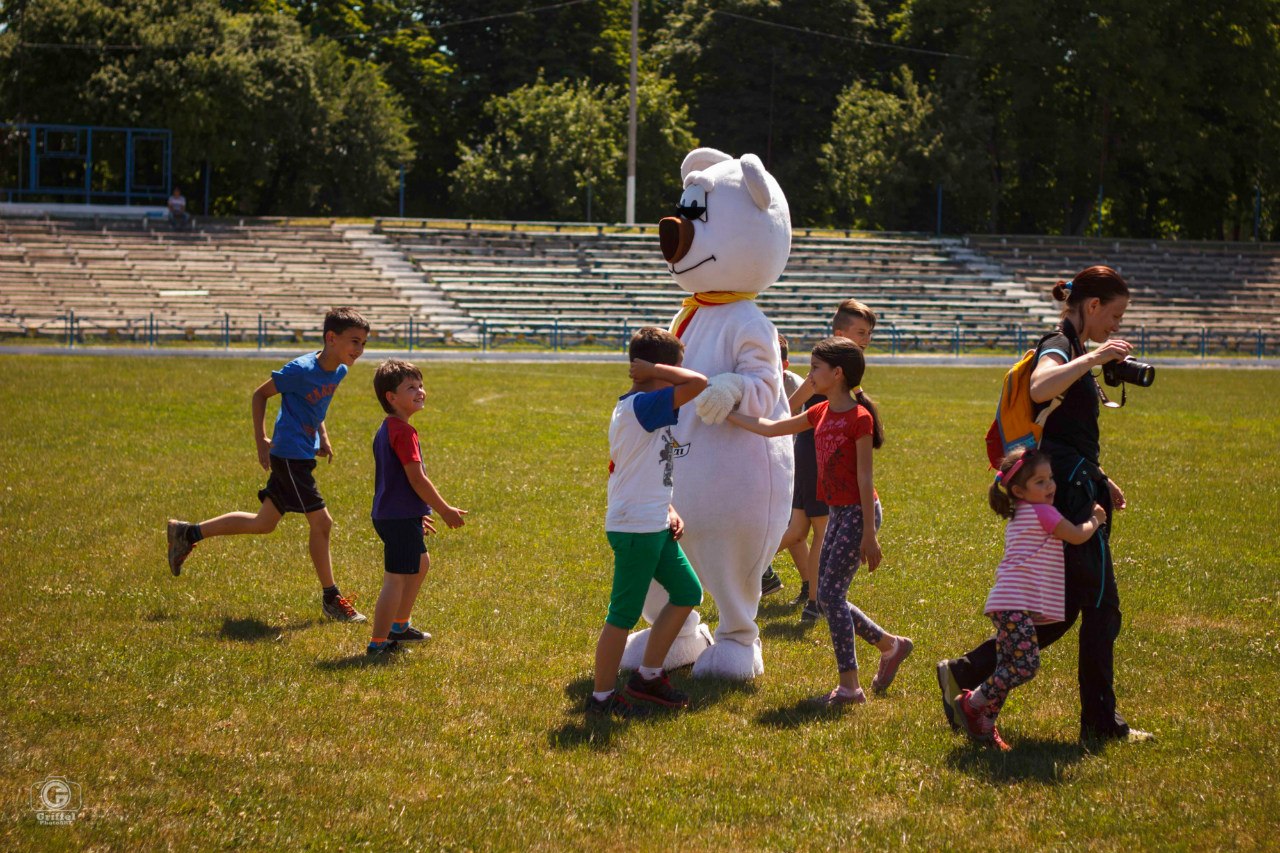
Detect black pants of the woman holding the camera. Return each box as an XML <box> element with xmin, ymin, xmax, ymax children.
<box><xmin>951</xmin><ymin>605</ymin><xmax>1129</xmax><ymax>738</ymax></box>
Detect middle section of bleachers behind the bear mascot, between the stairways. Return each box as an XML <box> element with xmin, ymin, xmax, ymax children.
<box><xmin>380</xmin><ymin>223</ymin><xmax>1042</xmax><ymax>348</ymax></box>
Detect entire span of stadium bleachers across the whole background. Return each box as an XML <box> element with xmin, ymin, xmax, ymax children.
<box><xmin>0</xmin><ymin>218</ymin><xmax>1280</xmax><ymax>351</ymax></box>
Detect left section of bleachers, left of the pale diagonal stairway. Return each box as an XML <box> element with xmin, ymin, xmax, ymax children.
<box><xmin>0</xmin><ymin>219</ymin><xmax>429</xmax><ymax>339</ymax></box>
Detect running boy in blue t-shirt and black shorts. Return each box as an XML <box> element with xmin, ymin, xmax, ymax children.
<box><xmin>168</xmin><ymin>307</ymin><xmax>369</xmax><ymax>622</ymax></box>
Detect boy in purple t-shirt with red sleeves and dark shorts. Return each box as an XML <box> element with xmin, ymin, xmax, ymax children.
<box><xmin>366</xmin><ymin>359</ymin><xmax>467</xmax><ymax>656</ymax></box>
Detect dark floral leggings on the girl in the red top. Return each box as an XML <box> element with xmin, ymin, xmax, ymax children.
<box><xmin>818</xmin><ymin>505</ymin><xmax>884</xmax><ymax>672</ymax></box>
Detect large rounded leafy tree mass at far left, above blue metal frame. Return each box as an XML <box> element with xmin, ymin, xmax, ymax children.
<box><xmin>0</xmin><ymin>0</ymin><xmax>412</xmax><ymax>214</ymax></box>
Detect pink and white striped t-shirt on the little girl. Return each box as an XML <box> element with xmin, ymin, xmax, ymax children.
<box><xmin>983</xmin><ymin>501</ymin><xmax>1065</xmax><ymax>625</ymax></box>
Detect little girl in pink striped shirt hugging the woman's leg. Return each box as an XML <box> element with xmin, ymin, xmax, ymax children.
<box><xmin>956</xmin><ymin>448</ymin><xmax>1107</xmax><ymax>749</ymax></box>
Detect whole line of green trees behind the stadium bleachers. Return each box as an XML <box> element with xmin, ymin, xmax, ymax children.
<box><xmin>0</xmin><ymin>0</ymin><xmax>1280</xmax><ymax>240</ymax></box>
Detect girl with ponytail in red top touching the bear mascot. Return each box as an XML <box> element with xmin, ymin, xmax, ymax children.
<box><xmin>728</xmin><ymin>338</ymin><xmax>913</xmax><ymax>704</ymax></box>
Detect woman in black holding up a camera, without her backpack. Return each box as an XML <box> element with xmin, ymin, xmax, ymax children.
<box><xmin>937</xmin><ymin>266</ymin><xmax>1151</xmax><ymax>740</ymax></box>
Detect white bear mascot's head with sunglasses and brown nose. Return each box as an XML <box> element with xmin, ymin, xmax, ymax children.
<box><xmin>658</xmin><ymin>149</ymin><xmax>791</xmax><ymax>293</ymax></box>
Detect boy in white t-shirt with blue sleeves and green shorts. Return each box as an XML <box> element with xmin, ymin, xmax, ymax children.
<box><xmin>586</xmin><ymin>327</ymin><xmax>707</xmax><ymax>717</ymax></box>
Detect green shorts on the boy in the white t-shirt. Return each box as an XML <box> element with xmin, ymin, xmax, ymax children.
<box><xmin>604</xmin><ymin>530</ymin><xmax>703</xmax><ymax>631</ymax></box>
